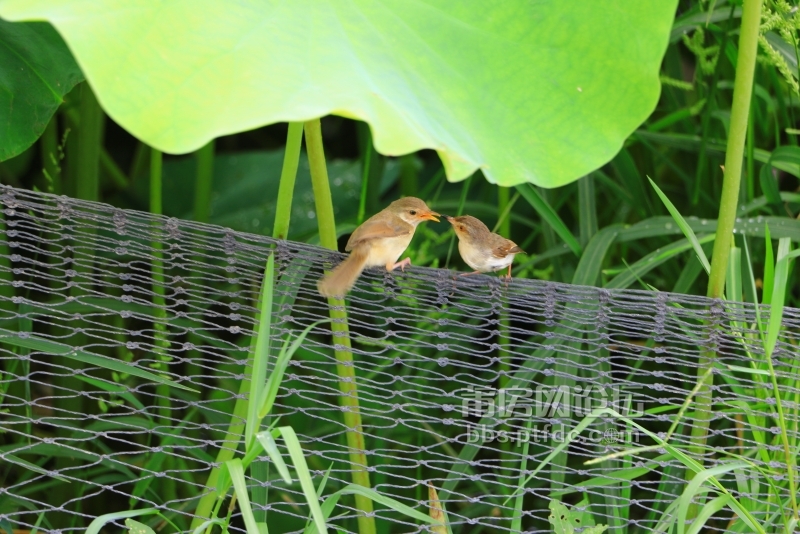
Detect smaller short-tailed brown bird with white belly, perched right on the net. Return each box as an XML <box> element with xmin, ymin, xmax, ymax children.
<box><xmin>446</xmin><ymin>215</ymin><xmax>525</xmax><ymax>280</ymax></box>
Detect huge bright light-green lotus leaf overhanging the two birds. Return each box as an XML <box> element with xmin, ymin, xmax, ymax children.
<box><xmin>0</xmin><ymin>0</ymin><xmax>677</xmax><ymax>187</ymax></box>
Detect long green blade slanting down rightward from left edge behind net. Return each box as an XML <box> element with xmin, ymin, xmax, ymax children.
<box><xmin>0</xmin><ymin>328</ymin><xmax>200</xmax><ymax>393</ymax></box>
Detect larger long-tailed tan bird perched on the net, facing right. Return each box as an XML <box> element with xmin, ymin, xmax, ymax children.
<box><xmin>317</xmin><ymin>197</ymin><xmax>439</xmax><ymax>297</ymax></box>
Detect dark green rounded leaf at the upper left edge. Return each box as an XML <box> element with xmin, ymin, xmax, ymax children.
<box><xmin>0</xmin><ymin>20</ymin><xmax>83</xmax><ymax>161</ymax></box>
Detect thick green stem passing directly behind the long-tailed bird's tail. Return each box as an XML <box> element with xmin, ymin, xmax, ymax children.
<box><xmin>304</xmin><ymin>119</ymin><xmax>376</xmax><ymax>534</ymax></box>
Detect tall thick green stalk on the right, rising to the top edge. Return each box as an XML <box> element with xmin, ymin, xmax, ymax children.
<box><xmin>687</xmin><ymin>0</ymin><xmax>762</xmax><ymax>519</ymax></box>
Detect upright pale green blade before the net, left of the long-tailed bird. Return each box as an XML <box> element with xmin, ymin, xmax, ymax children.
<box><xmin>244</xmin><ymin>254</ymin><xmax>275</xmax><ymax>454</ymax></box>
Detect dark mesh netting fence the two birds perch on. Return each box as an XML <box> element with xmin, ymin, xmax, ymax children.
<box><xmin>0</xmin><ymin>187</ymin><xmax>800</xmax><ymax>533</ymax></box>
